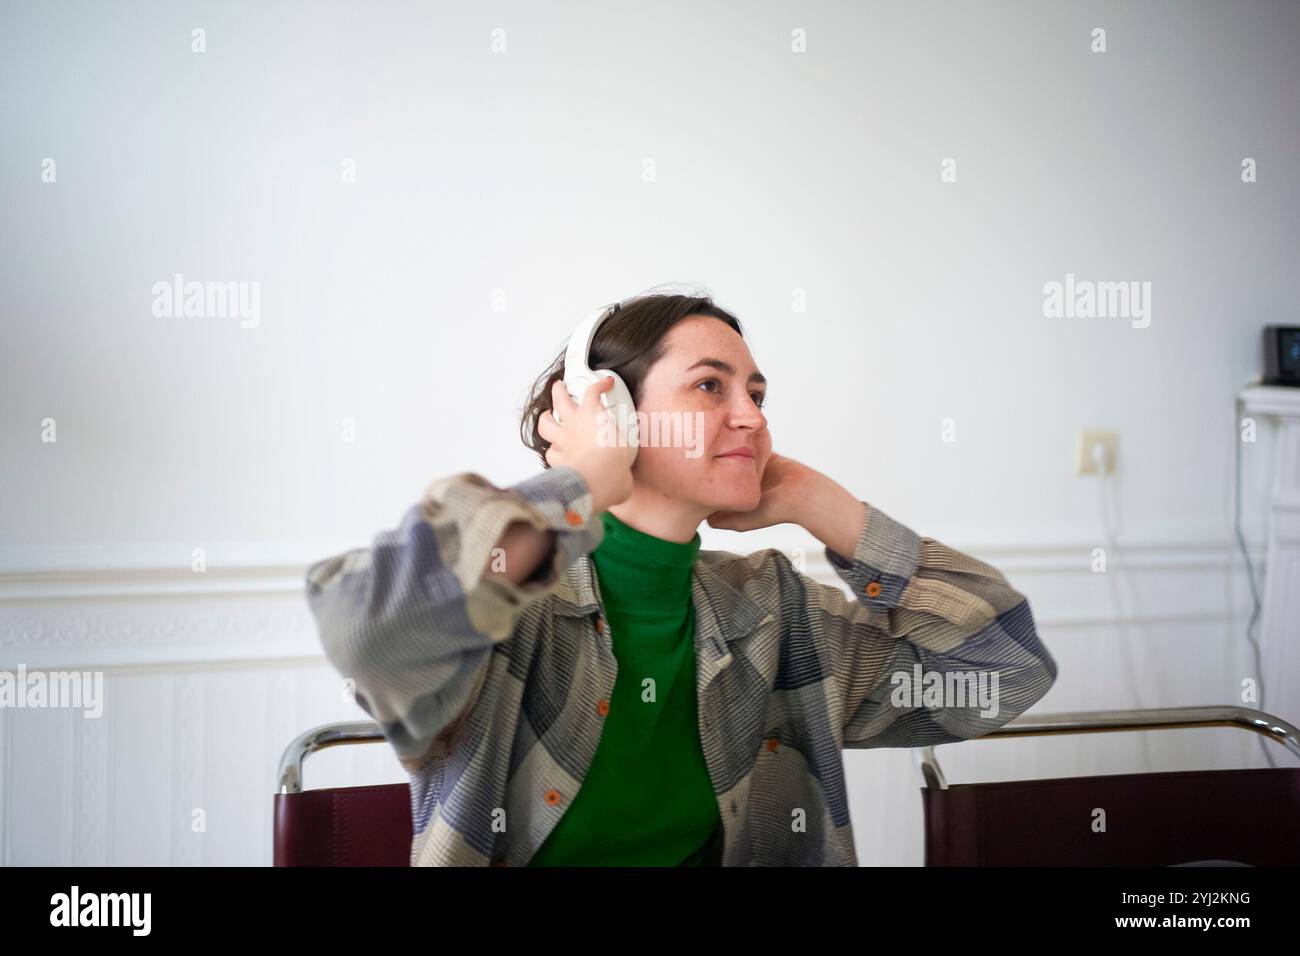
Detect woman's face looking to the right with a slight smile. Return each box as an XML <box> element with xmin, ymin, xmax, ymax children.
<box><xmin>633</xmin><ymin>315</ymin><xmax>772</xmax><ymax>520</ymax></box>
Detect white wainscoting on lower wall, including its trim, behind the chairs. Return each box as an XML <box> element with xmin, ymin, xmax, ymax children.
<box><xmin>0</xmin><ymin>541</ymin><xmax>1279</xmax><ymax>866</ymax></box>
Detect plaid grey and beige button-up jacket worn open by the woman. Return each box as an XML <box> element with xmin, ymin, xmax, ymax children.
<box><xmin>306</xmin><ymin>467</ymin><xmax>1057</xmax><ymax>866</ymax></box>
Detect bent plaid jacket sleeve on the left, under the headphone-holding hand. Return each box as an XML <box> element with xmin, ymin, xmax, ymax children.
<box><xmin>306</xmin><ymin>467</ymin><xmax>603</xmax><ymax>770</ymax></box>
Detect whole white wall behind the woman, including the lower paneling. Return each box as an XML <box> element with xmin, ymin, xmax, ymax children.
<box><xmin>0</xmin><ymin>3</ymin><xmax>1300</xmax><ymax>864</ymax></box>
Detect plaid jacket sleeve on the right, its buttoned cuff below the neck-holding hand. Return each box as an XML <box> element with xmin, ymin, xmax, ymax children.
<box><xmin>807</xmin><ymin>502</ymin><xmax>1057</xmax><ymax>748</ymax></box>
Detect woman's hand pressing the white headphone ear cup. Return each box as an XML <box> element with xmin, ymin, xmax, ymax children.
<box><xmin>537</xmin><ymin>376</ymin><xmax>633</xmax><ymax>515</ymax></box>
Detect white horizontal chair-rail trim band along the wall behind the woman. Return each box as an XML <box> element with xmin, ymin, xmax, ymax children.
<box><xmin>0</xmin><ymin>542</ymin><xmax>1265</xmax><ymax>670</ymax></box>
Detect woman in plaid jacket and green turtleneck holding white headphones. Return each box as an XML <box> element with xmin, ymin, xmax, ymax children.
<box><xmin>307</xmin><ymin>294</ymin><xmax>1057</xmax><ymax>866</ymax></box>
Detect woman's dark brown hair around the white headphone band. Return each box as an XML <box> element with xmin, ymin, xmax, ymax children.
<box><xmin>520</xmin><ymin>293</ymin><xmax>745</xmax><ymax>468</ymax></box>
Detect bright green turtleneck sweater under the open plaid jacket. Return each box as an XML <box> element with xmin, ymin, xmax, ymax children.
<box><xmin>528</xmin><ymin>511</ymin><xmax>722</xmax><ymax>866</ymax></box>
